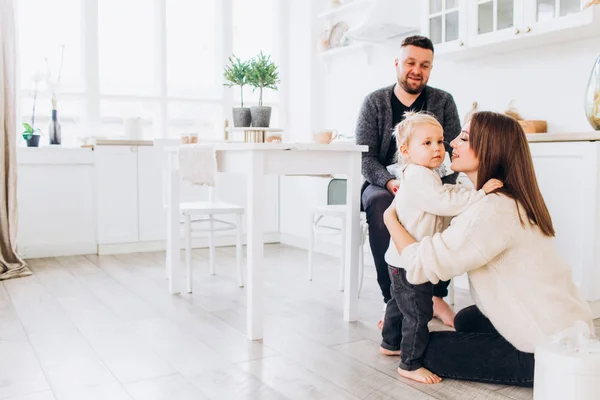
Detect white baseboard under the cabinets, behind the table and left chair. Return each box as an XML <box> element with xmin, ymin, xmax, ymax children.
<box><xmin>98</xmin><ymin>232</ymin><xmax>279</xmax><ymax>255</ymax></box>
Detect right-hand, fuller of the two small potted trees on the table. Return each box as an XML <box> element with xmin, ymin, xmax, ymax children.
<box><xmin>248</xmin><ymin>51</ymin><xmax>279</xmax><ymax>128</ymax></box>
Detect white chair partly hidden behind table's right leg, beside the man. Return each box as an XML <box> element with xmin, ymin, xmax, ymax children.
<box><xmin>308</xmin><ymin>179</ymin><xmax>368</xmax><ymax>295</ymax></box>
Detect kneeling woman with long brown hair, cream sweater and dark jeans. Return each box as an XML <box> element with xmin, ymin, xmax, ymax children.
<box><xmin>381</xmin><ymin>112</ymin><xmax>593</xmax><ymax>386</ymax></box>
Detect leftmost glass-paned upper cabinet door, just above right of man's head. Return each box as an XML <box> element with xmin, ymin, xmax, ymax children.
<box><xmin>422</xmin><ymin>0</ymin><xmax>467</xmax><ymax>53</ymax></box>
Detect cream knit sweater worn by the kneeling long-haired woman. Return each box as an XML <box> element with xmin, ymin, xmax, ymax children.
<box><xmin>402</xmin><ymin>194</ymin><xmax>594</xmax><ymax>353</ymax></box>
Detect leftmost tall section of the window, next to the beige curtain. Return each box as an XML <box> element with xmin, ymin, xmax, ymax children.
<box><xmin>16</xmin><ymin>0</ymin><xmax>84</xmax><ymax>143</ymax></box>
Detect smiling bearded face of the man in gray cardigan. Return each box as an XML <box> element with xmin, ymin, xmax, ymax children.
<box><xmin>395</xmin><ymin>46</ymin><xmax>433</xmax><ymax>94</ymax></box>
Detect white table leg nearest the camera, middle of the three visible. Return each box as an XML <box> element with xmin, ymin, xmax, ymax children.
<box><xmin>246</xmin><ymin>151</ymin><xmax>265</xmax><ymax>340</ymax></box>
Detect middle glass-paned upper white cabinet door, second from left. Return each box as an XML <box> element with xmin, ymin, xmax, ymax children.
<box><xmin>468</xmin><ymin>0</ymin><xmax>527</xmax><ymax>46</ymax></box>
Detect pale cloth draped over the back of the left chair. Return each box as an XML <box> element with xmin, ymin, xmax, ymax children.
<box><xmin>179</xmin><ymin>144</ymin><xmax>217</xmax><ymax>186</ymax></box>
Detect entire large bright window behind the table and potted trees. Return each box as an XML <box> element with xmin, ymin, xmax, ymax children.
<box><xmin>16</xmin><ymin>0</ymin><xmax>280</xmax><ymax>145</ymax></box>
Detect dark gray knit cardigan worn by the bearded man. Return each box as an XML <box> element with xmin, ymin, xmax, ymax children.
<box><xmin>356</xmin><ymin>85</ymin><xmax>461</xmax><ymax>187</ymax></box>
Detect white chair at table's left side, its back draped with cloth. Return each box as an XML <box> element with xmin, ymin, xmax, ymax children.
<box><xmin>154</xmin><ymin>139</ymin><xmax>244</xmax><ymax>293</ymax></box>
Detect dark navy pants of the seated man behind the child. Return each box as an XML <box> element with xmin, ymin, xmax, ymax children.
<box><xmin>362</xmin><ymin>183</ymin><xmax>450</xmax><ymax>304</ymax></box>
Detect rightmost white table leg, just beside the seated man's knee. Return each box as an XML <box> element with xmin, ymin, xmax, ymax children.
<box><xmin>344</xmin><ymin>153</ymin><xmax>361</xmax><ymax>322</ymax></box>
